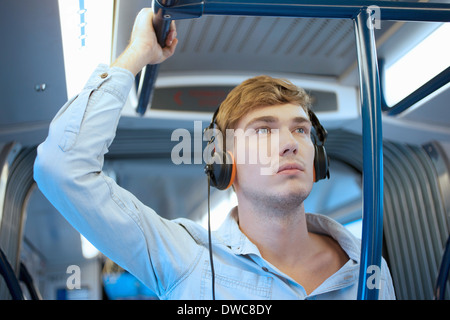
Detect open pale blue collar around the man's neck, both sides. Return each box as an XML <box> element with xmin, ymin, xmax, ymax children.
<box><xmin>215</xmin><ymin>207</ymin><xmax>361</xmax><ymax>263</ymax></box>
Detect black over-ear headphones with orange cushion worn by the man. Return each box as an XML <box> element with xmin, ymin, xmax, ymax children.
<box><xmin>204</xmin><ymin>107</ymin><xmax>330</xmax><ymax>190</ymax></box>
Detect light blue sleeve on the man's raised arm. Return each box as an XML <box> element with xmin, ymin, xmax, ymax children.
<box><xmin>34</xmin><ymin>65</ymin><xmax>202</xmax><ymax>295</ymax></box>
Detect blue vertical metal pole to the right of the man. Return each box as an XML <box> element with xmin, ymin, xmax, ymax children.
<box><xmin>354</xmin><ymin>8</ymin><xmax>383</xmax><ymax>300</ymax></box>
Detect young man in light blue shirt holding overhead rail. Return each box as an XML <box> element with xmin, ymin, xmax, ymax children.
<box><xmin>34</xmin><ymin>9</ymin><xmax>395</xmax><ymax>299</ymax></box>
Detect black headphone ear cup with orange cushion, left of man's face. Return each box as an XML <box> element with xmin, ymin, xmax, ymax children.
<box><xmin>210</xmin><ymin>151</ymin><xmax>236</xmax><ymax>190</ymax></box>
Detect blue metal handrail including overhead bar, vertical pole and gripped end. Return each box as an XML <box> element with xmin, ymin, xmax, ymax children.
<box><xmin>138</xmin><ymin>0</ymin><xmax>450</xmax><ymax>299</ymax></box>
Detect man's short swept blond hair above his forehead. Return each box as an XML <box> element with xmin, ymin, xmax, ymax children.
<box><xmin>216</xmin><ymin>76</ymin><xmax>311</xmax><ymax>132</ymax></box>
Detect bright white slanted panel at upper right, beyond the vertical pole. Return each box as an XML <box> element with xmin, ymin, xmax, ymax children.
<box><xmin>384</xmin><ymin>23</ymin><xmax>450</xmax><ymax>106</ymax></box>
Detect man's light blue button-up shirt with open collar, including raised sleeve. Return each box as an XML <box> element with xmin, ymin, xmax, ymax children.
<box><xmin>34</xmin><ymin>65</ymin><xmax>395</xmax><ymax>300</ymax></box>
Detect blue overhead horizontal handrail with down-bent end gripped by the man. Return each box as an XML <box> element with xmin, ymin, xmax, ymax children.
<box><xmin>136</xmin><ymin>0</ymin><xmax>450</xmax><ymax>115</ymax></box>
